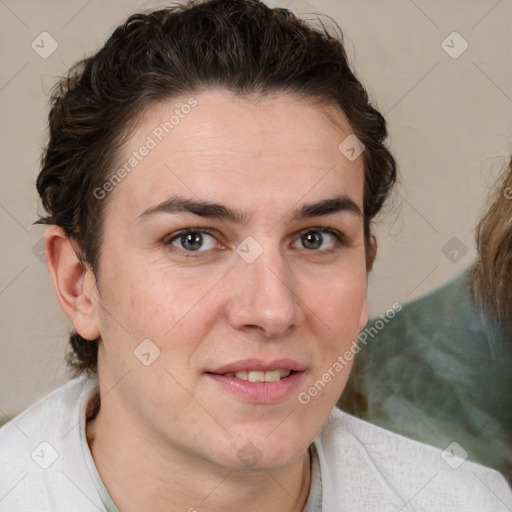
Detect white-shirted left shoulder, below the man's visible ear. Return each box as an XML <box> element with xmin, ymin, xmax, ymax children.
<box><xmin>0</xmin><ymin>378</ymin><xmax>103</xmax><ymax>512</ymax></box>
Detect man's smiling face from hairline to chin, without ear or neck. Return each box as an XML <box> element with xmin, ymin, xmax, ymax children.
<box><xmin>87</xmin><ymin>91</ymin><xmax>367</xmax><ymax>470</ymax></box>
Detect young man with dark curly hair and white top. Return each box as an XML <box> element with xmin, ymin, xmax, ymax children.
<box><xmin>0</xmin><ymin>0</ymin><xmax>512</xmax><ymax>512</ymax></box>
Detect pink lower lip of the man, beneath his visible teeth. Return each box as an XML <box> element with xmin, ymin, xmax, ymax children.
<box><xmin>206</xmin><ymin>372</ymin><xmax>304</xmax><ymax>404</ymax></box>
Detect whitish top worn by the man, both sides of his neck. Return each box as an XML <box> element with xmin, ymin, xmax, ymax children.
<box><xmin>0</xmin><ymin>378</ymin><xmax>512</xmax><ymax>512</ymax></box>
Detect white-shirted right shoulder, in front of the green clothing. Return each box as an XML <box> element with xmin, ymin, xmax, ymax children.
<box><xmin>315</xmin><ymin>409</ymin><xmax>512</xmax><ymax>512</ymax></box>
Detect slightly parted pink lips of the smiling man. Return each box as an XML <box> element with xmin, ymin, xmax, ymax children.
<box><xmin>205</xmin><ymin>359</ymin><xmax>305</xmax><ymax>404</ymax></box>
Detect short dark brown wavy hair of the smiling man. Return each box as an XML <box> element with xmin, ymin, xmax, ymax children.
<box><xmin>37</xmin><ymin>0</ymin><xmax>396</xmax><ymax>374</ymax></box>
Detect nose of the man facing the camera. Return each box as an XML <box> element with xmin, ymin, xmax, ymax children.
<box><xmin>227</xmin><ymin>243</ymin><xmax>304</xmax><ymax>338</ymax></box>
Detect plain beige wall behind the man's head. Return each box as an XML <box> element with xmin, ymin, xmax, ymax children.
<box><xmin>0</xmin><ymin>0</ymin><xmax>512</xmax><ymax>416</ymax></box>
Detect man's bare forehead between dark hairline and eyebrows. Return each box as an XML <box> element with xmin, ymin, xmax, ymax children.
<box><xmin>102</xmin><ymin>91</ymin><xmax>364</xmax><ymax>218</ymax></box>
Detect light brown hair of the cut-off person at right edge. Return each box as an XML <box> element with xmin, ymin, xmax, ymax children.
<box><xmin>469</xmin><ymin>159</ymin><xmax>512</xmax><ymax>328</ymax></box>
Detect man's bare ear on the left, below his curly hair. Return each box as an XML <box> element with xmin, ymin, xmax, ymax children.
<box><xmin>44</xmin><ymin>226</ymin><xmax>100</xmax><ymax>340</ymax></box>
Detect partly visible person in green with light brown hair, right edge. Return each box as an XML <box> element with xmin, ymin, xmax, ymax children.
<box><xmin>338</xmin><ymin>161</ymin><xmax>512</xmax><ymax>484</ymax></box>
